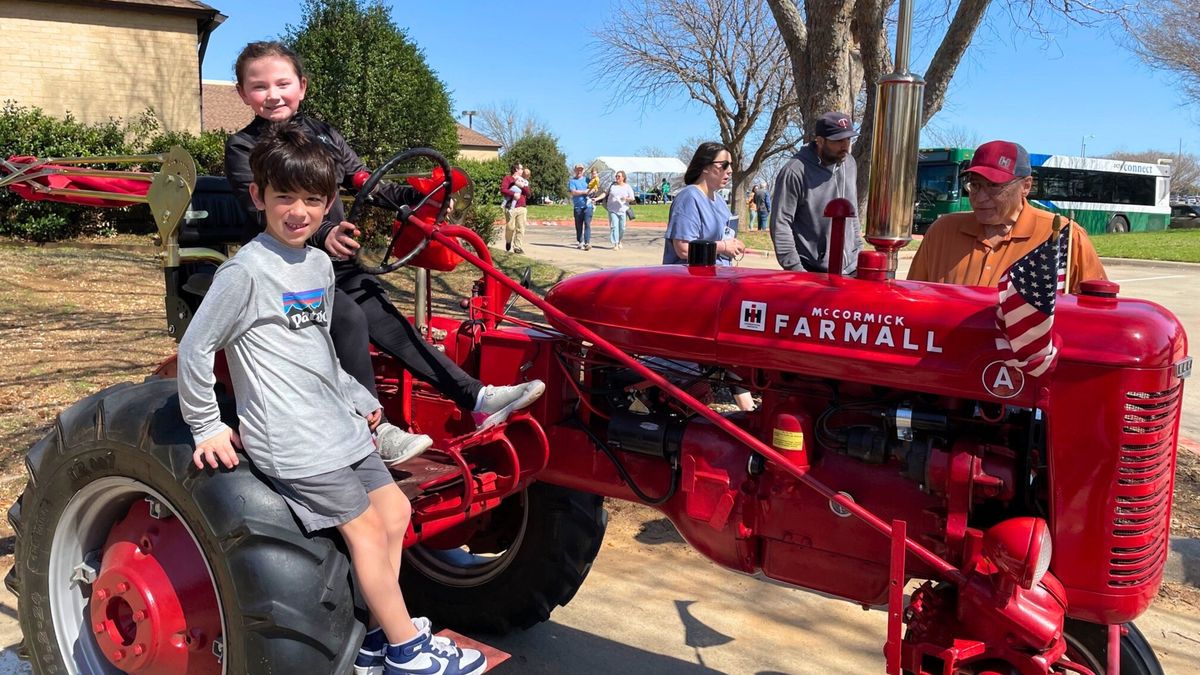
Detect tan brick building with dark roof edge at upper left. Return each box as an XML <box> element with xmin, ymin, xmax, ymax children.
<box><xmin>0</xmin><ymin>0</ymin><xmax>226</xmax><ymax>133</ymax></box>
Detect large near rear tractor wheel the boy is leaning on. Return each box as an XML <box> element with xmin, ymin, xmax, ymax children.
<box><xmin>8</xmin><ymin>380</ymin><xmax>362</xmax><ymax>675</ymax></box>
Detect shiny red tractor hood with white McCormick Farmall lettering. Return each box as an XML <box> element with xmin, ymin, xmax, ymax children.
<box><xmin>546</xmin><ymin>265</ymin><xmax>1187</xmax><ymax>405</ymax></box>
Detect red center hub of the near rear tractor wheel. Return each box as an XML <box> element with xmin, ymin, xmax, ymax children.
<box><xmin>89</xmin><ymin>500</ymin><xmax>221</xmax><ymax>675</ymax></box>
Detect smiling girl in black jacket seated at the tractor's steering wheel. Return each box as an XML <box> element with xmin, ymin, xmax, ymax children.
<box><xmin>224</xmin><ymin>42</ymin><xmax>545</xmax><ymax>466</ymax></box>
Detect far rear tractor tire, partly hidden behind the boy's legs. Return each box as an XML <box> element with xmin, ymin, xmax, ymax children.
<box><xmin>400</xmin><ymin>483</ymin><xmax>608</xmax><ymax>633</ymax></box>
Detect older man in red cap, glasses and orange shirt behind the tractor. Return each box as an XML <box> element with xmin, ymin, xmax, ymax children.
<box><xmin>908</xmin><ymin>141</ymin><xmax>1106</xmax><ymax>293</ymax></box>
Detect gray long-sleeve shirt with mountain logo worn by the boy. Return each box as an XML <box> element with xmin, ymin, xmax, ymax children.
<box><xmin>179</xmin><ymin>233</ymin><xmax>379</xmax><ymax>479</ymax></box>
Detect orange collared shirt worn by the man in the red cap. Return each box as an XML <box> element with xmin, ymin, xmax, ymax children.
<box><xmin>908</xmin><ymin>202</ymin><xmax>1108</xmax><ymax>293</ymax></box>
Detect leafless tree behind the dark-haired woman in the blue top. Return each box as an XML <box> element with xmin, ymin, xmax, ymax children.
<box><xmin>594</xmin><ymin>0</ymin><xmax>799</xmax><ymax>219</ymax></box>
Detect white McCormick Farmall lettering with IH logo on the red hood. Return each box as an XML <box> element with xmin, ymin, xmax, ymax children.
<box><xmin>738</xmin><ymin>300</ymin><xmax>942</xmax><ymax>354</ymax></box>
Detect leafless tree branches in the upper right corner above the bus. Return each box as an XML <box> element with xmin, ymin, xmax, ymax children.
<box><xmin>1129</xmin><ymin>0</ymin><xmax>1200</xmax><ymax>102</ymax></box>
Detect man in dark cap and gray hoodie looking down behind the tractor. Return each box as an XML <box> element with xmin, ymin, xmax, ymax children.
<box><xmin>770</xmin><ymin>112</ymin><xmax>863</xmax><ymax>274</ymax></box>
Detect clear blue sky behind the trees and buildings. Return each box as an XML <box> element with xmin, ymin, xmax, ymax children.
<box><xmin>204</xmin><ymin>0</ymin><xmax>1200</xmax><ymax>162</ymax></box>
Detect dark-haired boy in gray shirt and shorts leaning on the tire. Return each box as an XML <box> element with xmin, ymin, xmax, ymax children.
<box><xmin>179</xmin><ymin>124</ymin><xmax>486</xmax><ymax>675</ymax></box>
